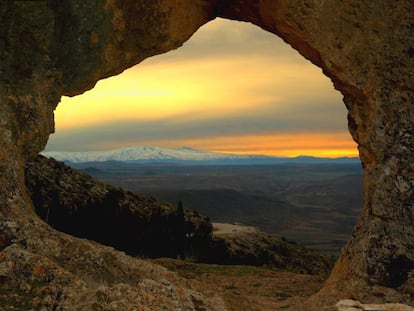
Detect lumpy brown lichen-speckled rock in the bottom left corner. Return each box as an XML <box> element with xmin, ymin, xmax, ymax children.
<box><xmin>0</xmin><ymin>240</ymin><xmax>226</xmax><ymax>311</ymax></box>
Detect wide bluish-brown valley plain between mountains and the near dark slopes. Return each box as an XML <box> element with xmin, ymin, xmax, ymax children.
<box><xmin>70</xmin><ymin>161</ymin><xmax>363</xmax><ymax>256</ymax></box>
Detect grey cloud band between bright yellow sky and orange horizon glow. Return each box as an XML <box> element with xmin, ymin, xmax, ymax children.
<box><xmin>44</xmin><ymin>104</ymin><xmax>347</xmax><ymax>150</ymax></box>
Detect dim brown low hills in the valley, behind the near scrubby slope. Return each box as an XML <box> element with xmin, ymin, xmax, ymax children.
<box><xmin>144</xmin><ymin>185</ymin><xmax>362</xmax><ymax>255</ymax></box>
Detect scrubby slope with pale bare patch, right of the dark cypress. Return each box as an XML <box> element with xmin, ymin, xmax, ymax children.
<box><xmin>205</xmin><ymin>223</ymin><xmax>334</xmax><ymax>275</ymax></box>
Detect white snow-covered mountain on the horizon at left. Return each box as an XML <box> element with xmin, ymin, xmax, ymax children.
<box><xmin>42</xmin><ymin>147</ymin><xmax>251</xmax><ymax>163</ymax></box>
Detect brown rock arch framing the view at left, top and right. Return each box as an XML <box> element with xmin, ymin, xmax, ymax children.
<box><xmin>0</xmin><ymin>0</ymin><xmax>414</xmax><ymax>310</ymax></box>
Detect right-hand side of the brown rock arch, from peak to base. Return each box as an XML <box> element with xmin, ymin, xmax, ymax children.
<box><xmin>220</xmin><ymin>0</ymin><xmax>414</xmax><ymax>308</ymax></box>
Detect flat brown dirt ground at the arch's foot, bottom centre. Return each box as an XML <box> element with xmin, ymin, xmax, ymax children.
<box><xmin>153</xmin><ymin>258</ymin><xmax>327</xmax><ymax>311</ymax></box>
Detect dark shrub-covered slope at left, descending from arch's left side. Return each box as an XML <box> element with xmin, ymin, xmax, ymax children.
<box><xmin>26</xmin><ymin>156</ymin><xmax>212</xmax><ymax>257</ymax></box>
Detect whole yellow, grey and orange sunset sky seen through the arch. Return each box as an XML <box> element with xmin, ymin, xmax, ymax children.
<box><xmin>46</xmin><ymin>19</ymin><xmax>357</xmax><ymax>157</ymax></box>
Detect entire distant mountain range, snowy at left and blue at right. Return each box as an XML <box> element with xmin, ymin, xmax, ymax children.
<box><xmin>42</xmin><ymin>146</ymin><xmax>359</xmax><ymax>164</ymax></box>
